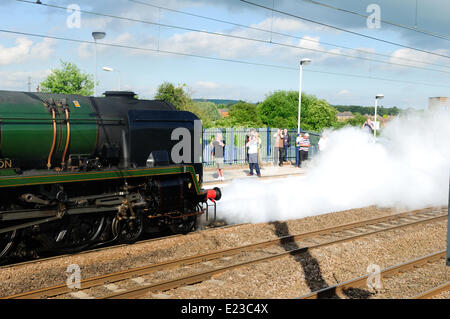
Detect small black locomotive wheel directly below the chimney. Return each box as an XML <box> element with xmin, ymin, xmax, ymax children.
<box><xmin>111</xmin><ymin>214</ymin><xmax>144</xmax><ymax>244</ymax></box>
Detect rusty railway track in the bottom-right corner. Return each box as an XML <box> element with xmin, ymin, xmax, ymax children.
<box><xmin>299</xmin><ymin>250</ymin><xmax>450</xmax><ymax>299</ymax></box>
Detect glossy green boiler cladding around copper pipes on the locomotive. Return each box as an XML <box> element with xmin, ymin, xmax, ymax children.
<box><xmin>0</xmin><ymin>91</ymin><xmax>98</xmax><ymax>166</ymax></box>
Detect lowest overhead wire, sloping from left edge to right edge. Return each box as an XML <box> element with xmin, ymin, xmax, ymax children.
<box><xmin>0</xmin><ymin>29</ymin><xmax>450</xmax><ymax>88</ymax></box>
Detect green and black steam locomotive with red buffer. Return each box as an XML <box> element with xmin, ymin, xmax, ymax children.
<box><xmin>0</xmin><ymin>91</ymin><xmax>221</xmax><ymax>262</ymax></box>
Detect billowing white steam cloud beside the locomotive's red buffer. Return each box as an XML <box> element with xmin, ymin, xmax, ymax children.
<box><xmin>218</xmin><ymin>111</ymin><xmax>450</xmax><ymax>223</ymax></box>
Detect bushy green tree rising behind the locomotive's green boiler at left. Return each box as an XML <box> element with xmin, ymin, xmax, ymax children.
<box><xmin>40</xmin><ymin>60</ymin><xmax>94</xmax><ymax>96</ymax></box>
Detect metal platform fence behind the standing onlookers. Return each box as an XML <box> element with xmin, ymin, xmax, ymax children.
<box><xmin>203</xmin><ymin>127</ymin><xmax>320</xmax><ymax>166</ymax></box>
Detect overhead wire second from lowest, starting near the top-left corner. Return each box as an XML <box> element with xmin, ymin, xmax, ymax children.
<box><xmin>16</xmin><ymin>0</ymin><xmax>450</xmax><ymax>74</ymax></box>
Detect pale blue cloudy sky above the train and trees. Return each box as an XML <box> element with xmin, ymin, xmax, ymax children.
<box><xmin>0</xmin><ymin>0</ymin><xmax>450</xmax><ymax>109</ymax></box>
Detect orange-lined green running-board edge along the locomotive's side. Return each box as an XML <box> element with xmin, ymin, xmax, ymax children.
<box><xmin>0</xmin><ymin>166</ymin><xmax>201</xmax><ymax>194</ymax></box>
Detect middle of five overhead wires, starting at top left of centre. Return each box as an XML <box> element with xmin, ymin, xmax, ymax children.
<box><xmin>128</xmin><ymin>0</ymin><xmax>450</xmax><ymax>68</ymax></box>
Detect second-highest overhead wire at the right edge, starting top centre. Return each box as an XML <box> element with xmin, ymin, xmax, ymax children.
<box><xmin>239</xmin><ymin>0</ymin><xmax>450</xmax><ymax>59</ymax></box>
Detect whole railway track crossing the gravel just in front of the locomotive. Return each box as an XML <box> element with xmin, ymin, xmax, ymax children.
<box><xmin>6</xmin><ymin>209</ymin><xmax>447</xmax><ymax>299</ymax></box>
